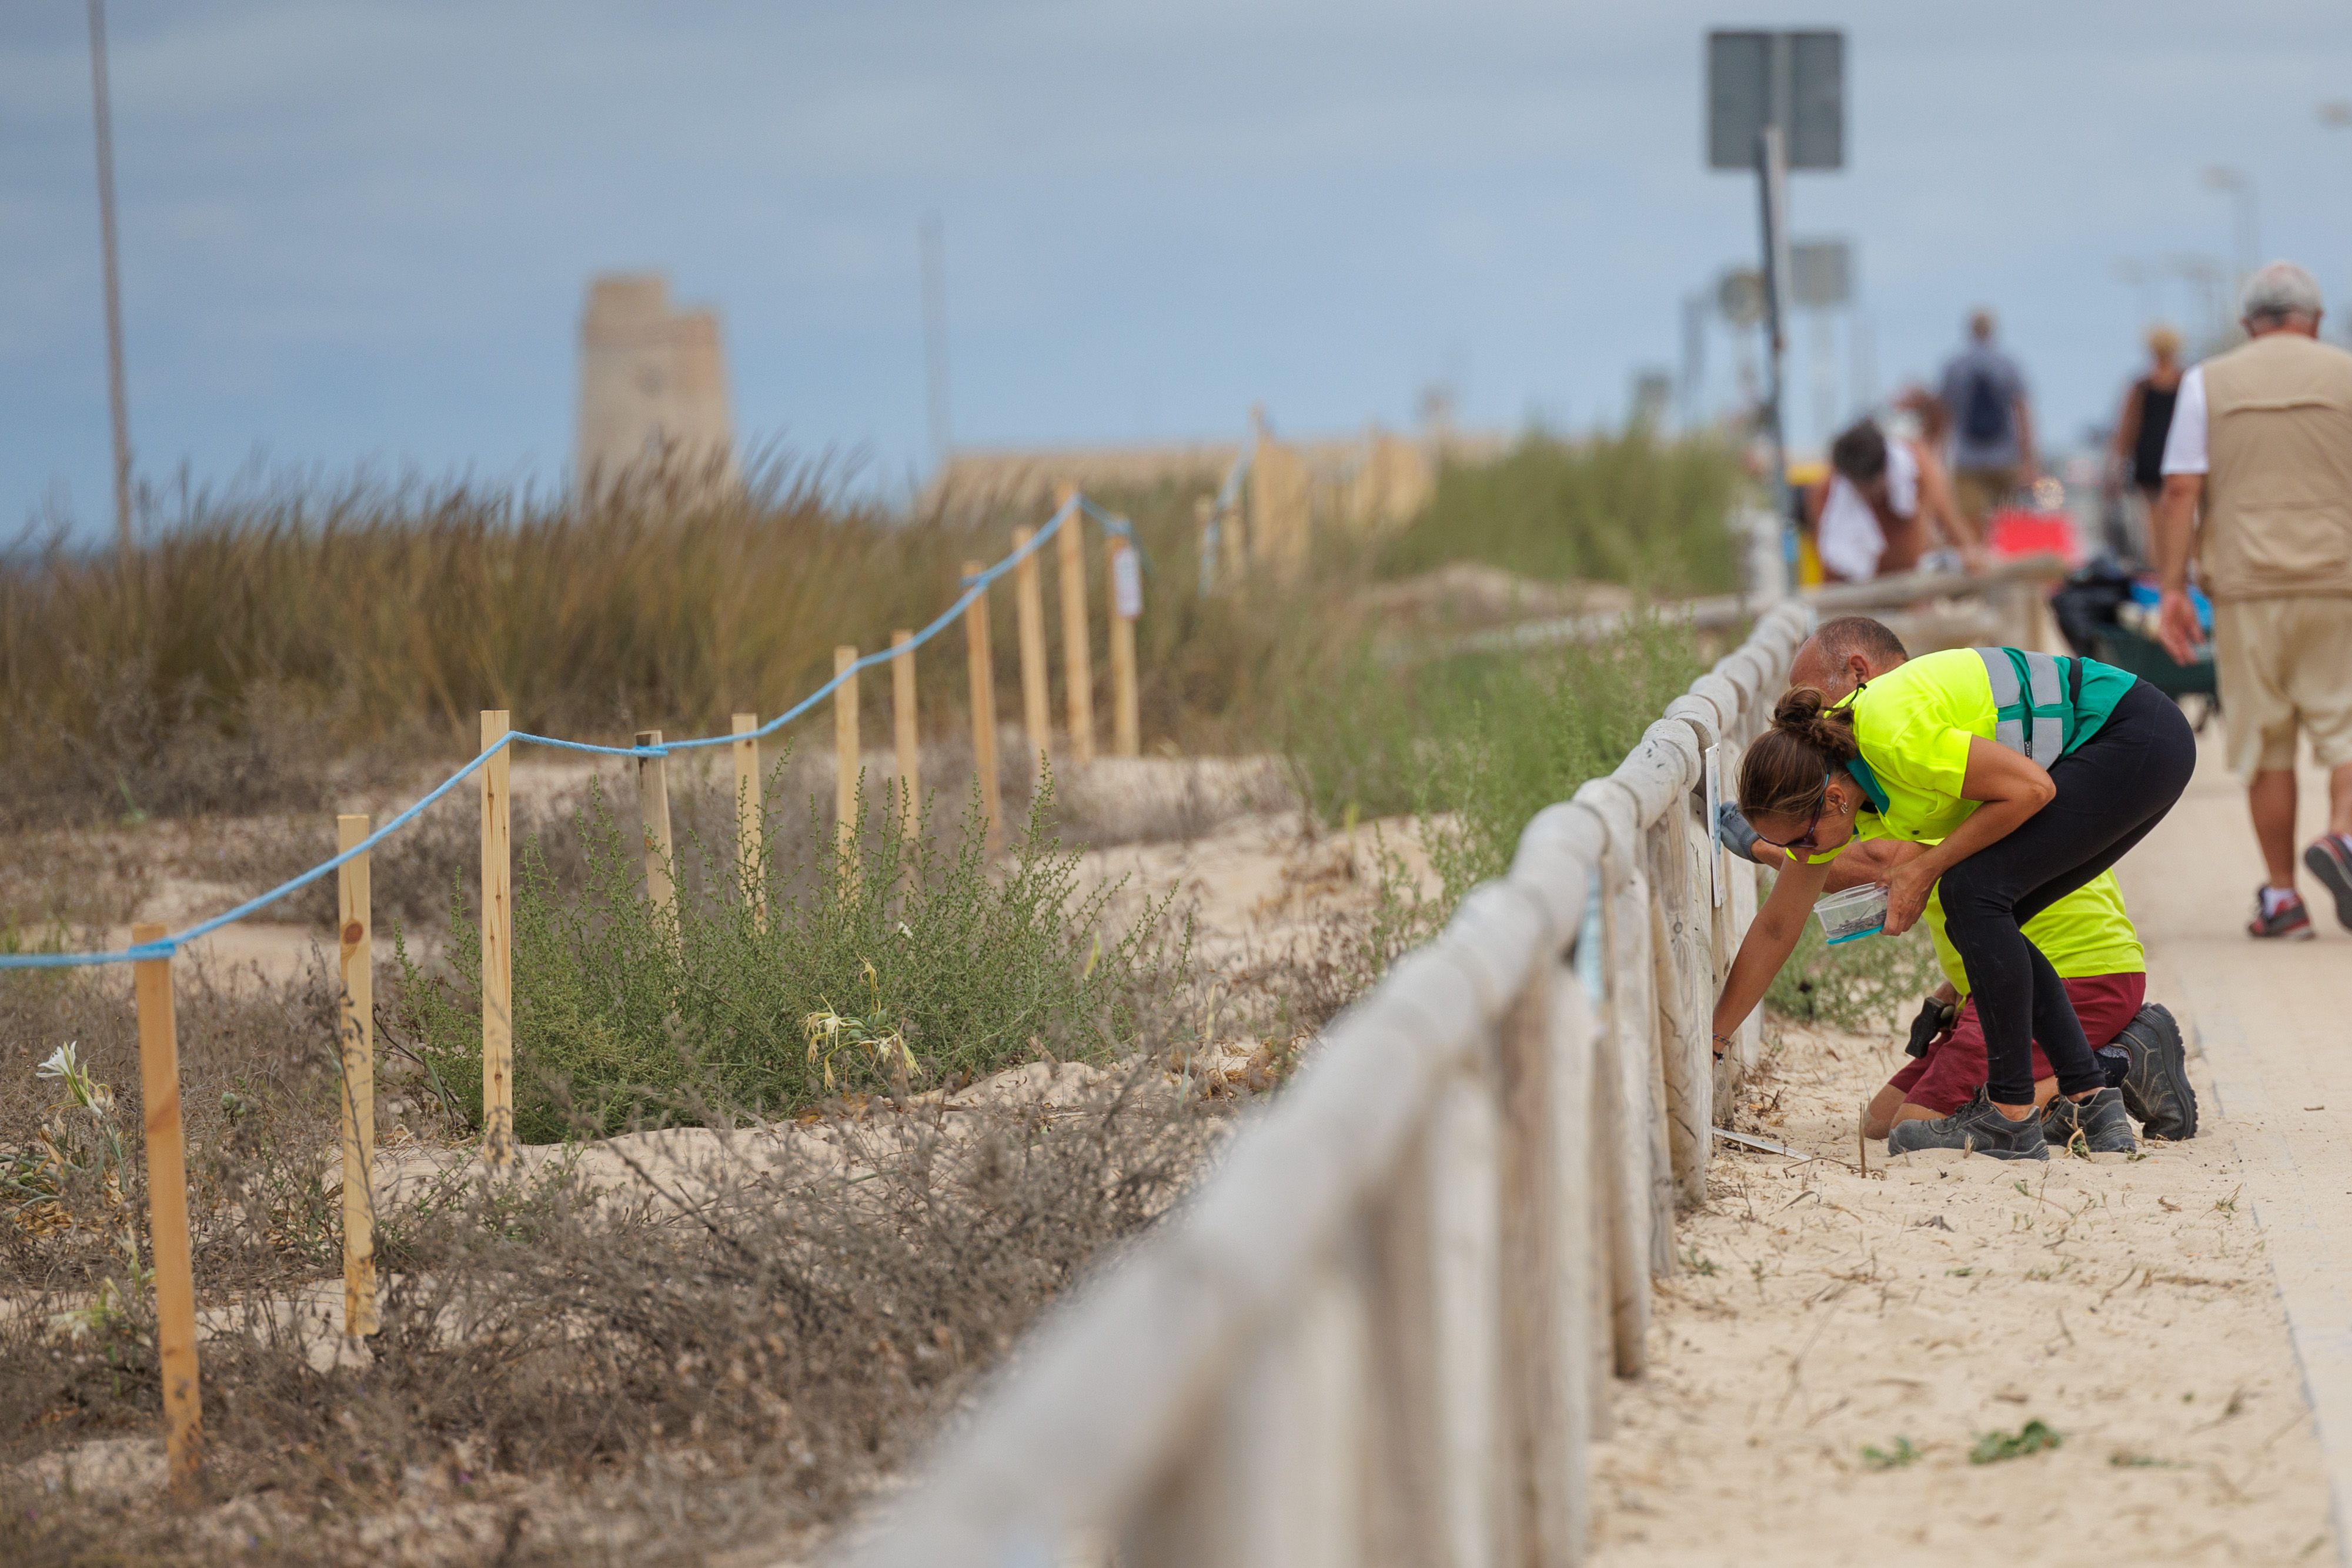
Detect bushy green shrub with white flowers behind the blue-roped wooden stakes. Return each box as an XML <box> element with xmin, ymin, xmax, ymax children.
<box><xmin>393</xmin><ymin>781</ymin><xmax>1188</xmax><ymax>1142</ymax></box>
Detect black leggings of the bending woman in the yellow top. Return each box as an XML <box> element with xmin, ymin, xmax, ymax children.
<box><xmin>1938</xmin><ymin>682</ymin><xmax>2197</xmax><ymax>1105</ymax></box>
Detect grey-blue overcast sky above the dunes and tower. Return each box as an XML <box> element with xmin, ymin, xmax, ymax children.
<box><xmin>0</xmin><ymin>0</ymin><xmax>2352</xmax><ymax>531</ymax></box>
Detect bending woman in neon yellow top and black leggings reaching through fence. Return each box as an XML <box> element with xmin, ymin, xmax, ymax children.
<box><xmin>1715</xmin><ymin>637</ymin><xmax>2197</xmax><ymax>1159</ymax></box>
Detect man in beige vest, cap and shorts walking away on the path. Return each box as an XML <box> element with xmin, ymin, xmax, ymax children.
<box><xmin>2154</xmin><ymin>261</ymin><xmax>2352</xmax><ymax>938</ymax></box>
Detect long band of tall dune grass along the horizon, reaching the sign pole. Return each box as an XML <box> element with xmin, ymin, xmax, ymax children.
<box><xmin>0</xmin><ymin>435</ymin><xmax>1733</xmax><ymax>825</ymax></box>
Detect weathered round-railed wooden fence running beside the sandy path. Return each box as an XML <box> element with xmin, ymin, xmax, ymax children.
<box><xmin>835</xmin><ymin>604</ymin><xmax>1813</xmax><ymax>1568</ymax></box>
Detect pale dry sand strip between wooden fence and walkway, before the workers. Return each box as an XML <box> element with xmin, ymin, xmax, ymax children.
<box><xmin>1592</xmin><ymin>1027</ymin><xmax>2336</xmax><ymax>1568</ymax></box>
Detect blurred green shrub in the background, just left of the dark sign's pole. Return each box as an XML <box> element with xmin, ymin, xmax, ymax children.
<box><xmin>1378</xmin><ymin>426</ymin><xmax>1740</xmax><ymax>595</ymax></box>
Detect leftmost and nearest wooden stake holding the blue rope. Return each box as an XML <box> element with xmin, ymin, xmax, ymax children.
<box><xmin>132</xmin><ymin>924</ymin><xmax>205</xmax><ymax>1493</ymax></box>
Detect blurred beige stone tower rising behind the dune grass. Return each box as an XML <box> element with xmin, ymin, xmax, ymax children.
<box><xmin>572</xmin><ymin>273</ymin><xmax>736</xmax><ymax>494</ymax></box>
